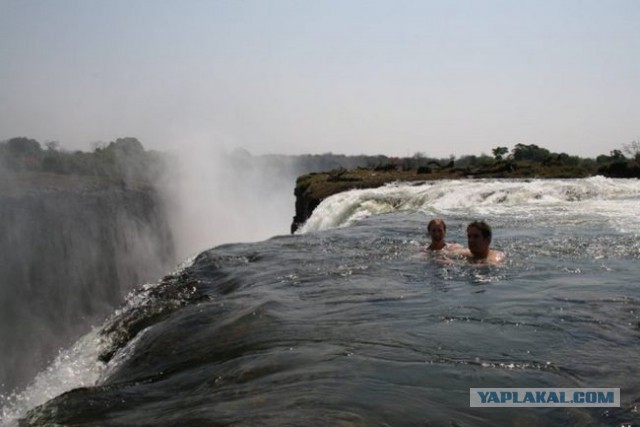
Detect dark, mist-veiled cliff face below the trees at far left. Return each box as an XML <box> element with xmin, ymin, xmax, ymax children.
<box><xmin>0</xmin><ymin>179</ymin><xmax>176</xmax><ymax>393</ymax></box>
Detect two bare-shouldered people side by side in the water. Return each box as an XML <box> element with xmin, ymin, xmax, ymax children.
<box><xmin>426</xmin><ymin>218</ymin><xmax>506</xmax><ymax>264</ymax></box>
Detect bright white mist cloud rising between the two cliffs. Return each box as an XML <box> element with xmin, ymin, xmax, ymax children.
<box><xmin>159</xmin><ymin>141</ymin><xmax>296</xmax><ymax>258</ymax></box>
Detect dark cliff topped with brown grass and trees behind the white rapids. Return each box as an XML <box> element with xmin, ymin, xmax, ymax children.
<box><xmin>291</xmin><ymin>141</ymin><xmax>640</xmax><ymax>233</ymax></box>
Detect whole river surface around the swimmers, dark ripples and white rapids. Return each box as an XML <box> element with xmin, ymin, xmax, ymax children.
<box><xmin>1</xmin><ymin>177</ymin><xmax>640</xmax><ymax>426</ymax></box>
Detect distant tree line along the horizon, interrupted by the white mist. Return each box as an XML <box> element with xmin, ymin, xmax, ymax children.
<box><xmin>0</xmin><ymin>137</ymin><xmax>640</xmax><ymax>182</ymax></box>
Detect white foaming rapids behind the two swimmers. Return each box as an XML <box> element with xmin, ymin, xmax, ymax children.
<box><xmin>298</xmin><ymin>176</ymin><xmax>640</xmax><ymax>233</ymax></box>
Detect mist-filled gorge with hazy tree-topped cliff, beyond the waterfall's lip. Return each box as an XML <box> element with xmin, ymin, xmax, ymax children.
<box><xmin>0</xmin><ymin>138</ymin><xmax>378</xmax><ymax>396</ymax></box>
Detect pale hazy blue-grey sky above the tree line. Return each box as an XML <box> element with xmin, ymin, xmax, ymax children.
<box><xmin>0</xmin><ymin>0</ymin><xmax>640</xmax><ymax>157</ymax></box>
